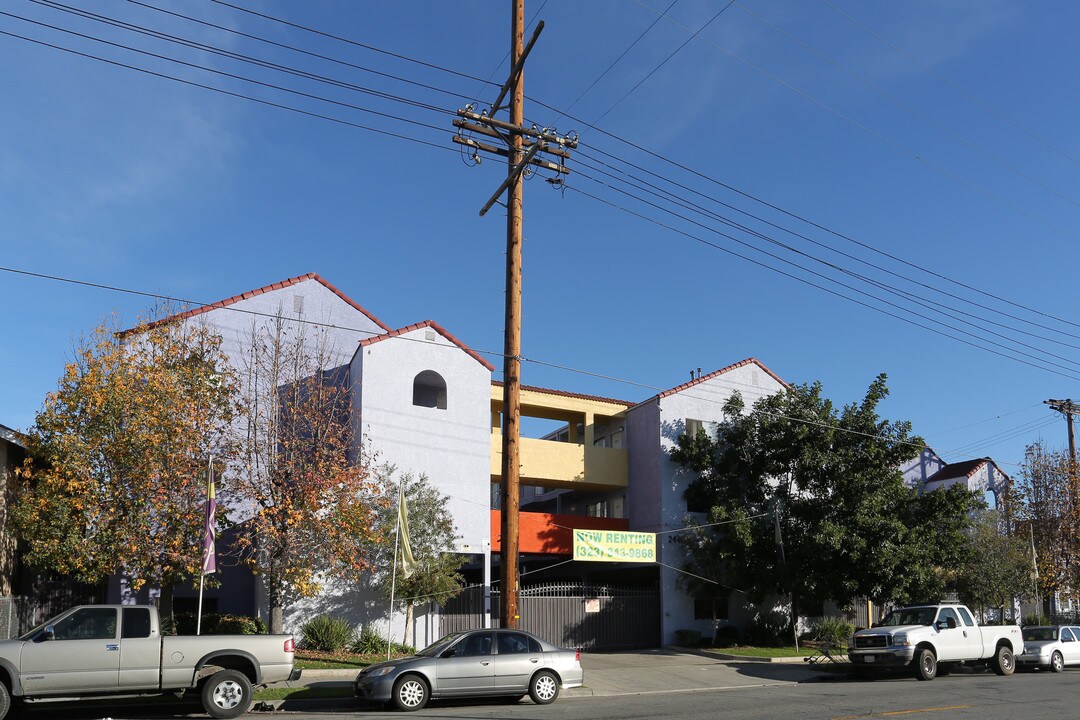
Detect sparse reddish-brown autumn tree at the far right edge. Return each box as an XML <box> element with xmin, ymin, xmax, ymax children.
<box><xmin>1013</xmin><ymin>441</ymin><xmax>1080</xmax><ymax>596</ymax></box>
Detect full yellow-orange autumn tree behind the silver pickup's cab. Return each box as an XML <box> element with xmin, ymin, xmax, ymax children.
<box><xmin>13</xmin><ymin>307</ymin><xmax>234</xmax><ymax>612</ymax></box>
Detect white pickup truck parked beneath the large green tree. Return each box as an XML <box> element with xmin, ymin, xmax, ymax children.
<box><xmin>848</xmin><ymin>604</ymin><xmax>1024</xmax><ymax>680</ymax></box>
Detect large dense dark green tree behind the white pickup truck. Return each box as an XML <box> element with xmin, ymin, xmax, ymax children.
<box><xmin>673</xmin><ymin>375</ymin><xmax>977</xmax><ymax>634</ymax></box>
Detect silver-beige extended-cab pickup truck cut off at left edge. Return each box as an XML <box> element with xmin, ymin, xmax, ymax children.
<box><xmin>0</xmin><ymin>604</ymin><xmax>300</xmax><ymax>720</ymax></box>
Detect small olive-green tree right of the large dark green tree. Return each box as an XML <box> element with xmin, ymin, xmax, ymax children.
<box><xmin>956</xmin><ymin>510</ymin><xmax>1031</xmax><ymax>621</ymax></box>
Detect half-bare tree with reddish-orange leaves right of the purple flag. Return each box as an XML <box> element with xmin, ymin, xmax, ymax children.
<box><xmin>228</xmin><ymin>314</ymin><xmax>386</xmax><ymax>633</ymax></box>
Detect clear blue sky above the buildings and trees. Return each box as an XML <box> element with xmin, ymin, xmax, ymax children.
<box><xmin>0</xmin><ymin>0</ymin><xmax>1080</xmax><ymax>473</ymax></box>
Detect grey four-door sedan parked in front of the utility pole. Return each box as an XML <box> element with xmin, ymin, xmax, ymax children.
<box><xmin>353</xmin><ymin>629</ymin><xmax>584</xmax><ymax>710</ymax></box>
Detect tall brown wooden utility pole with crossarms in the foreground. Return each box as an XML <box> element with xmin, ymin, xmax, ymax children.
<box><xmin>454</xmin><ymin>0</ymin><xmax>577</xmax><ymax>627</ymax></box>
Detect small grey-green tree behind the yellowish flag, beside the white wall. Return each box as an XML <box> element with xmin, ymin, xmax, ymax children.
<box><xmin>378</xmin><ymin>465</ymin><xmax>465</xmax><ymax>643</ymax></box>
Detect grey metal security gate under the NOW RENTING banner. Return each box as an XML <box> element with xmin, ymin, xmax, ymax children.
<box><xmin>440</xmin><ymin>582</ymin><xmax>660</xmax><ymax>650</ymax></box>
